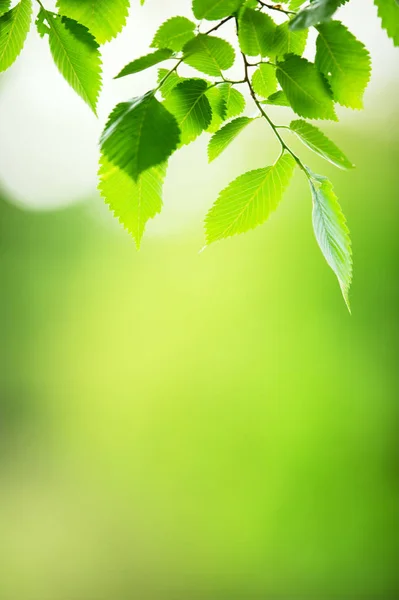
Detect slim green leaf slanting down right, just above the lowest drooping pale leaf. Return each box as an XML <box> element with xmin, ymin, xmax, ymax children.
<box><xmin>290</xmin><ymin>119</ymin><xmax>354</xmax><ymax>169</ymax></box>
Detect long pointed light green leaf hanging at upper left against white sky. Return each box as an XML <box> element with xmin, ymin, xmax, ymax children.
<box><xmin>37</xmin><ymin>9</ymin><xmax>101</xmax><ymax>114</ymax></box>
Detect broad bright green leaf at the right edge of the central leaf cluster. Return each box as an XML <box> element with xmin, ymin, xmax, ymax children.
<box><xmin>315</xmin><ymin>21</ymin><xmax>371</xmax><ymax>108</ymax></box>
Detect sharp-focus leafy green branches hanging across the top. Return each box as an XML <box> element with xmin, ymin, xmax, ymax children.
<box><xmin>0</xmin><ymin>0</ymin><xmax>399</xmax><ymax>308</ymax></box>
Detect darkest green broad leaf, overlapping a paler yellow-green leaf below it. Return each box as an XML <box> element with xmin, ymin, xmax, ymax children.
<box><xmin>100</xmin><ymin>92</ymin><xmax>180</xmax><ymax>181</ymax></box>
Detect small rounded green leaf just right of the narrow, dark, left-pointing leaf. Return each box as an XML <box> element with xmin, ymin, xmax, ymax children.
<box><xmin>183</xmin><ymin>33</ymin><xmax>235</xmax><ymax>77</ymax></box>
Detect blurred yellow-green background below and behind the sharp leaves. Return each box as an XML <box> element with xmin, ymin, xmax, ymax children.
<box><xmin>0</xmin><ymin>0</ymin><xmax>399</xmax><ymax>600</ymax></box>
